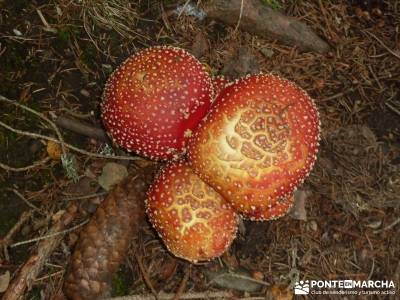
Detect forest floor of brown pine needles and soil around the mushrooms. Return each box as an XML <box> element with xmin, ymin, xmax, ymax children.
<box><xmin>0</xmin><ymin>0</ymin><xmax>400</xmax><ymax>299</ymax></box>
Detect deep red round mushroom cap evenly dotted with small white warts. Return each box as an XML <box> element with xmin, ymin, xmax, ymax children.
<box><xmin>101</xmin><ymin>46</ymin><xmax>213</xmax><ymax>160</ymax></box>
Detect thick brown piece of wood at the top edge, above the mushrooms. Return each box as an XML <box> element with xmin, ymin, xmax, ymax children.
<box><xmin>204</xmin><ymin>0</ymin><xmax>330</xmax><ymax>53</ymax></box>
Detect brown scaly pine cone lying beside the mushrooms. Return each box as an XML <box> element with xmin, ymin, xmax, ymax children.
<box><xmin>63</xmin><ymin>172</ymin><xmax>154</xmax><ymax>300</ymax></box>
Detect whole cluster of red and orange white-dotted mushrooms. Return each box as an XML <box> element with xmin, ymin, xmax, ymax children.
<box><xmin>101</xmin><ymin>46</ymin><xmax>320</xmax><ymax>262</ymax></box>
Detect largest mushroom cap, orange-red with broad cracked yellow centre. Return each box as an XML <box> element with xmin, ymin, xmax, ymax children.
<box><xmin>188</xmin><ymin>75</ymin><xmax>320</xmax><ymax>220</ymax></box>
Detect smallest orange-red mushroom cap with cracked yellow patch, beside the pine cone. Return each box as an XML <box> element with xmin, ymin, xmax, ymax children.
<box><xmin>146</xmin><ymin>161</ymin><xmax>238</xmax><ymax>262</ymax></box>
